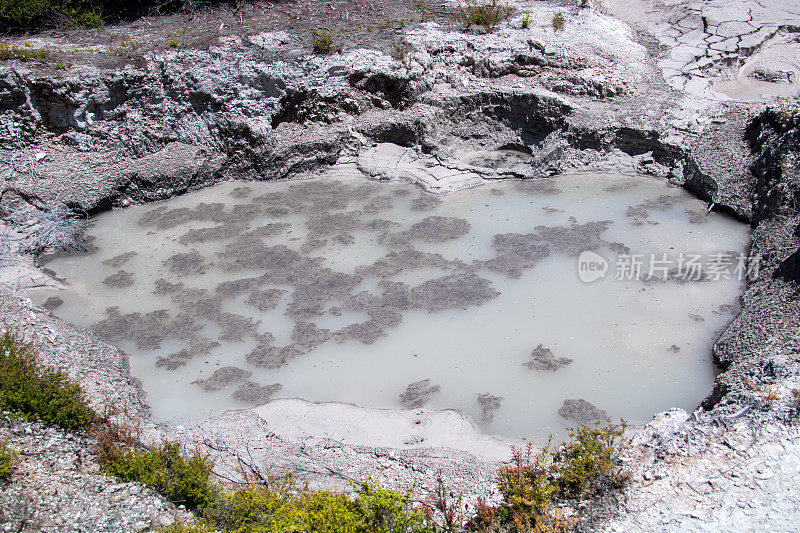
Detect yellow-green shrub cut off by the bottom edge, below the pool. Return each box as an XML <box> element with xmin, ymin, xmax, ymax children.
<box><xmin>204</xmin><ymin>477</ymin><xmax>435</xmax><ymax>533</ymax></box>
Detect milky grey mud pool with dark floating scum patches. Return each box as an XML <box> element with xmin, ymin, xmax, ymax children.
<box><xmin>29</xmin><ymin>167</ymin><xmax>748</xmax><ymax>440</ymax></box>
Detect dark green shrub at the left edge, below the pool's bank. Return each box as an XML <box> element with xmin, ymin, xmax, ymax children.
<box><xmin>0</xmin><ymin>332</ymin><xmax>97</xmax><ymax>430</ymax></box>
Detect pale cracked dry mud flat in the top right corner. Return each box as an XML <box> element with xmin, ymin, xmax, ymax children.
<box><xmin>605</xmin><ymin>0</ymin><xmax>800</xmax><ymax>103</ymax></box>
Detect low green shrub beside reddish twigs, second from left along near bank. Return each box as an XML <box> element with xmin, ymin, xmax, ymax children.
<box><xmin>97</xmin><ymin>432</ymin><xmax>217</xmax><ymax>509</ymax></box>
